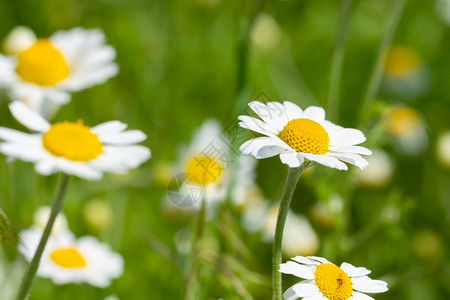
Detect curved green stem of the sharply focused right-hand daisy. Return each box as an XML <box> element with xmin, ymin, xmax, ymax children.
<box><xmin>272</xmin><ymin>162</ymin><xmax>312</xmax><ymax>300</ymax></box>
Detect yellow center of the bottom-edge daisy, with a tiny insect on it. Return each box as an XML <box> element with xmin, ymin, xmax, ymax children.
<box><xmin>314</xmin><ymin>264</ymin><xmax>353</xmax><ymax>300</ymax></box>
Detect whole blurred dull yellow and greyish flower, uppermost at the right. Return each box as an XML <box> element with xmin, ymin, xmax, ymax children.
<box><xmin>383</xmin><ymin>46</ymin><xmax>430</xmax><ymax>98</ymax></box>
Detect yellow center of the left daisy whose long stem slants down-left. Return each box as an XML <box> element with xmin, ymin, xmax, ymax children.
<box><xmin>42</xmin><ymin>120</ymin><xmax>103</xmax><ymax>161</ymax></box>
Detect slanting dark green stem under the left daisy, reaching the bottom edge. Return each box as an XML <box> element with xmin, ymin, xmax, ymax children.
<box><xmin>16</xmin><ymin>173</ymin><xmax>70</xmax><ymax>300</ymax></box>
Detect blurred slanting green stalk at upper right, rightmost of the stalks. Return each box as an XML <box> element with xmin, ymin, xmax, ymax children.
<box><xmin>359</xmin><ymin>0</ymin><xmax>406</xmax><ymax>124</ymax></box>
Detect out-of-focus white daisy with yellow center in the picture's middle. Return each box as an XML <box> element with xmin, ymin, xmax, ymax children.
<box><xmin>168</xmin><ymin>119</ymin><xmax>255</xmax><ymax>214</ymax></box>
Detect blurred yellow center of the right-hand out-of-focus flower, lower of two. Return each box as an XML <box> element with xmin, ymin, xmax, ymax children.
<box><xmin>384</xmin><ymin>106</ymin><xmax>421</xmax><ymax>136</ymax></box>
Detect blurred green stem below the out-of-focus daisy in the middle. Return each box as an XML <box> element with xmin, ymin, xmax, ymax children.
<box><xmin>184</xmin><ymin>199</ymin><xmax>206</xmax><ymax>300</ymax></box>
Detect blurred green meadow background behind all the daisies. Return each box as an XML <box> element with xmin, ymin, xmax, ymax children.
<box><xmin>0</xmin><ymin>0</ymin><xmax>450</xmax><ymax>300</ymax></box>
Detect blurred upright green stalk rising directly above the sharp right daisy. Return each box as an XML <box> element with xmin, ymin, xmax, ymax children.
<box><xmin>327</xmin><ymin>0</ymin><xmax>352</xmax><ymax>121</ymax></box>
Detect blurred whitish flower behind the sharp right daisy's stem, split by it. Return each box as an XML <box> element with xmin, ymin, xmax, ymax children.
<box><xmin>242</xmin><ymin>200</ymin><xmax>319</xmax><ymax>257</ymax></box>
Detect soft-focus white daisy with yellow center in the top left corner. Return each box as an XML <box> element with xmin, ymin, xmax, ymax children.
<box><xmin>0</xmin><ymin>28</ymin><xmax>118</xmax><ymax>114</ymax></box>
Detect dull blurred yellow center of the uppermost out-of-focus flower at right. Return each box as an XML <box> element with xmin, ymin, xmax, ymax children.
<box><xmin>384</xmin><ymin>47</ymin><xmax>420</xmax><ymax>77</ymax></box>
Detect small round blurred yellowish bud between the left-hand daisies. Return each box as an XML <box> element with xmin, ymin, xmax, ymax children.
<box><xmin>83</xmin><ymin>199</ymin><xmax>113</xmax><ymax>231</ymax></box>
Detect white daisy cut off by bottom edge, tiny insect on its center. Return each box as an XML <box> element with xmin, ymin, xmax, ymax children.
<box><xmin>279</xmin><ymin>256</ymin><xmax>388</xmax><ymax>300</ymax></box>
